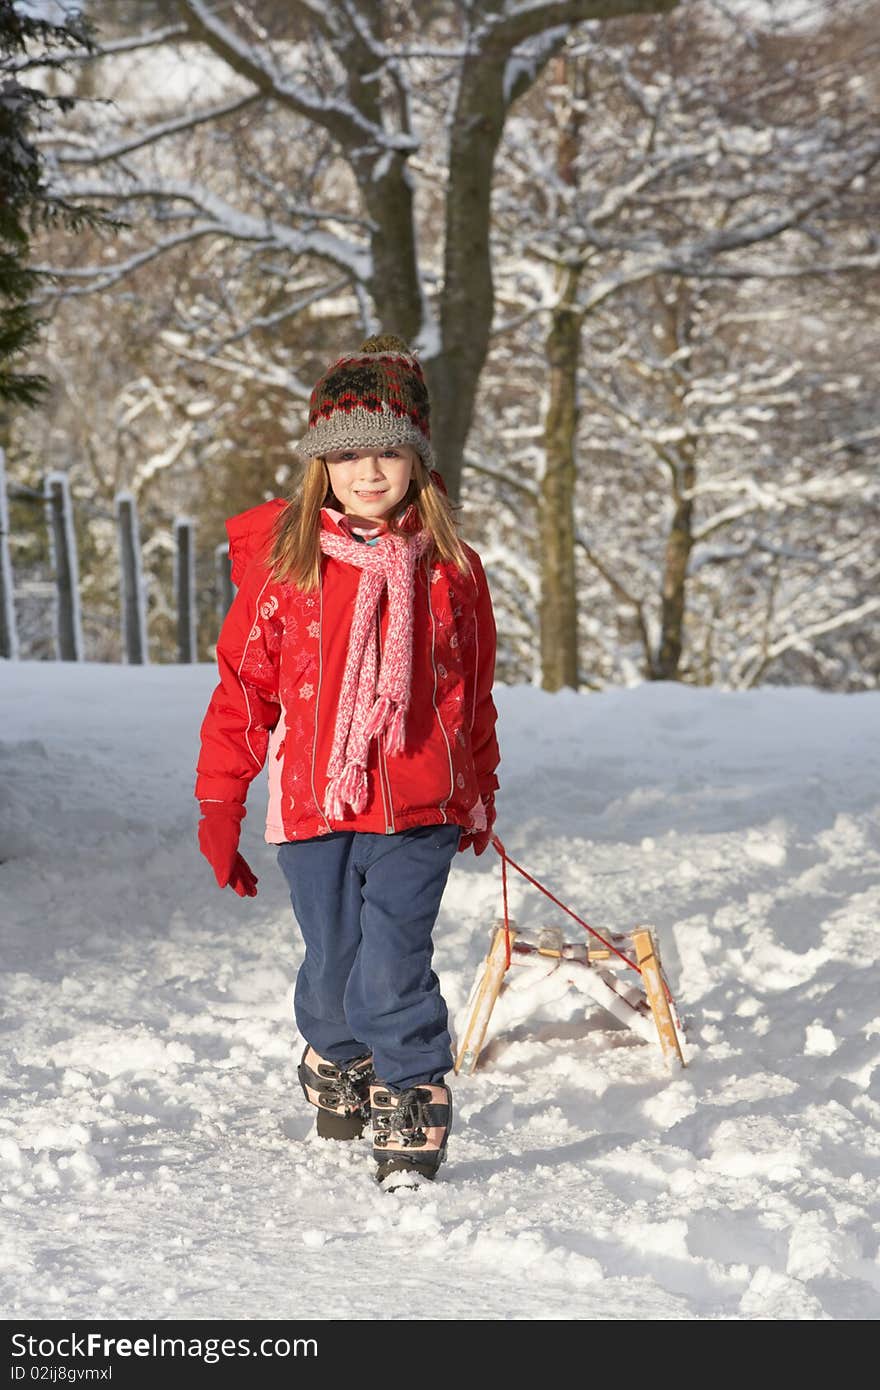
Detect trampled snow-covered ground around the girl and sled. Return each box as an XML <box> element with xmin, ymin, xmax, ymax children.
<box><xmin>0</xmin><ymin>662</ymin><xmax>880</xmax><ymax>1319</ymax></box>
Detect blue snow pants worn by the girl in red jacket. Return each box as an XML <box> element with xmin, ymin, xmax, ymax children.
<box><xmin>278</xmin><ymin>823</ymin><xmax>462</xmax><ymax>1091</ymax></box>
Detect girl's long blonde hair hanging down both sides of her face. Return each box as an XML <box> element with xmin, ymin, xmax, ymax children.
<box><xmin>267</xmin><ymin>450</ymin><xmax>473</xmax><ymax>591</ymax></box>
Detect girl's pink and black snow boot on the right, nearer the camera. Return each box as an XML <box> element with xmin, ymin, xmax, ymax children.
<box><xmin>370</xmin><ymin>1081</ymin><xmax>452</xmax><ymax>1193</ymax></box>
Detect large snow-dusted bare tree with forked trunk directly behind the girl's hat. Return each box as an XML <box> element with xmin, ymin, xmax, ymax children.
<box><xmin>32</xmin><ymin>0</ymin><xmax>676</xmax><ymax>496</ymax></box>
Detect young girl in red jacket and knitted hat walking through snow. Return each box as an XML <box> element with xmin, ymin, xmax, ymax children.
<box><xmin>195</xmin><ymin>335</ymin><xmax>500</xmax><ymax>1190</ymax></box>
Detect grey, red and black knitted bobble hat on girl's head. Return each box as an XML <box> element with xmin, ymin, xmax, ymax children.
<box><xmin>296</xmin><ymin>334</ymin><xmax>435</xmax><ymax>468</ymax></box>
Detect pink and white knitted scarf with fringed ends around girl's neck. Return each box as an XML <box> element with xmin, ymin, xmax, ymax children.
<box><xmin>320</xmin><ymin>530</ymin><xmax>431</xmax><ymax>820</ymax></box>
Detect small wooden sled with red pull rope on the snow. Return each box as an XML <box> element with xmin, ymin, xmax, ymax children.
<box><xmin>455</xmin><ymin>835</ymin><xmax>687</xmax><ymax>1074</ymax></box>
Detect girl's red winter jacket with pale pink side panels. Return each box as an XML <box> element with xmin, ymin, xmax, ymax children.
<box><xmin>195</xmin><ymin>498</ymin><xmax>500</xmax><ymax>844</ymax></box>
